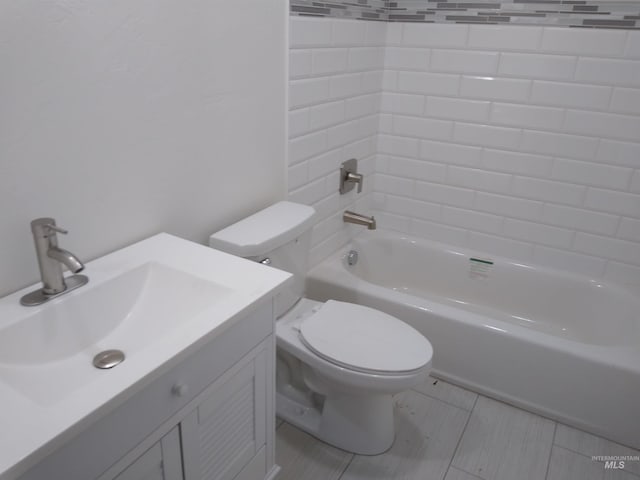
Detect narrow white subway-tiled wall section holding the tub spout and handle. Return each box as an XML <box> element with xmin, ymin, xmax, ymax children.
<box><xmin>288</xmin><ymin>16</ymin><xmax>387</xmax><ymax>264</ymax></box>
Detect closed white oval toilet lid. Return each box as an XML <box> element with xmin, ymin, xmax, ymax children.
<box><xmin>300</xmin><ymin>300</ymin><xmax>433</xmax><ymax>374</ymax></box>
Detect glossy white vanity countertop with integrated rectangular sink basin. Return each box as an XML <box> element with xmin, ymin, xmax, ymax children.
<box><xmin>0</xmin><ymin>233</ymin><xmax>291</xmax><ymax>480</ymax></box>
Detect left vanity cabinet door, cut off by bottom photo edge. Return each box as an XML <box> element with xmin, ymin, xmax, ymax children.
<box><xmin>114</xmin><ymin>427</ymin><xmax>183</xmax><ymax>480</ymax></box>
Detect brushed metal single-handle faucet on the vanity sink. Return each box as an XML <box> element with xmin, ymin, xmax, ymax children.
<box><xmin>20</xmin><ymin>217</ymin><xmax>89</xmax><ymax>306</ymax></box>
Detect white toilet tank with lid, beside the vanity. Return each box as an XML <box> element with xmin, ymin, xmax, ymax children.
<box><xmin>209</xmin><ymin>201</ymin><xmax>315</xmax><ymax>317</ymax></box>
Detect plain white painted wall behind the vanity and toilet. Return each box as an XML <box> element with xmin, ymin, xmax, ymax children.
<box><xmin>0</xmin><ymin>0</ymin><xmax>288</xmax><ymax>294</ymax></box>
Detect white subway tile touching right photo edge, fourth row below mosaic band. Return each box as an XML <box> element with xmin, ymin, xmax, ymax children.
<box><xmin>564</xmin><ymin>110</ymin><xmax>640</xmax><ymax>141</ymax></box>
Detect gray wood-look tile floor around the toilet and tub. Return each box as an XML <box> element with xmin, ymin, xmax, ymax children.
<box><xmin>276</xmin><ymin>378</ymin><xmax>640</xmax><ymax>480</ymax></box>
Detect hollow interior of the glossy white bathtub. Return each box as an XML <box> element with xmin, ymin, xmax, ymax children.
<box><xmin>343</xmin><ymin>231</ymin><xmax>640</xmax><ymax>345</ymax></box>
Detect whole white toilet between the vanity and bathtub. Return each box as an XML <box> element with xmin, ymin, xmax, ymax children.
<box><xmin>209</xmin><ymin>202</ymin><xmax>433</xmax><ymax>455</ymax></box>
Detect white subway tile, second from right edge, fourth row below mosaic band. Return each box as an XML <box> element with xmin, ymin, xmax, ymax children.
<box><xmin>491</xmin><ymin>103</ymin><xmax>564</xmax><ymax>130</ymax></box>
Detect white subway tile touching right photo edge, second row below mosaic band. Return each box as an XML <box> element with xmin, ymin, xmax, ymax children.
<box><xmin>575</xmin><ymin>57</ymin><xmax>640</xmax><ymax>87</ymax></box>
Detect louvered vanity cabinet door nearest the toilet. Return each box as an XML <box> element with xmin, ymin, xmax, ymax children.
<box><xmin>180</xmin><ymin>348</ymin><xmax>268</xmax><ymax>480</ymax></box>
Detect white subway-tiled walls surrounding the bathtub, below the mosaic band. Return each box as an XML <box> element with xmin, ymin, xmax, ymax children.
<box><xmin>290</xmin><ymin>17</ymin><xmax>640</xmax><ymax>285</ymax></box>
